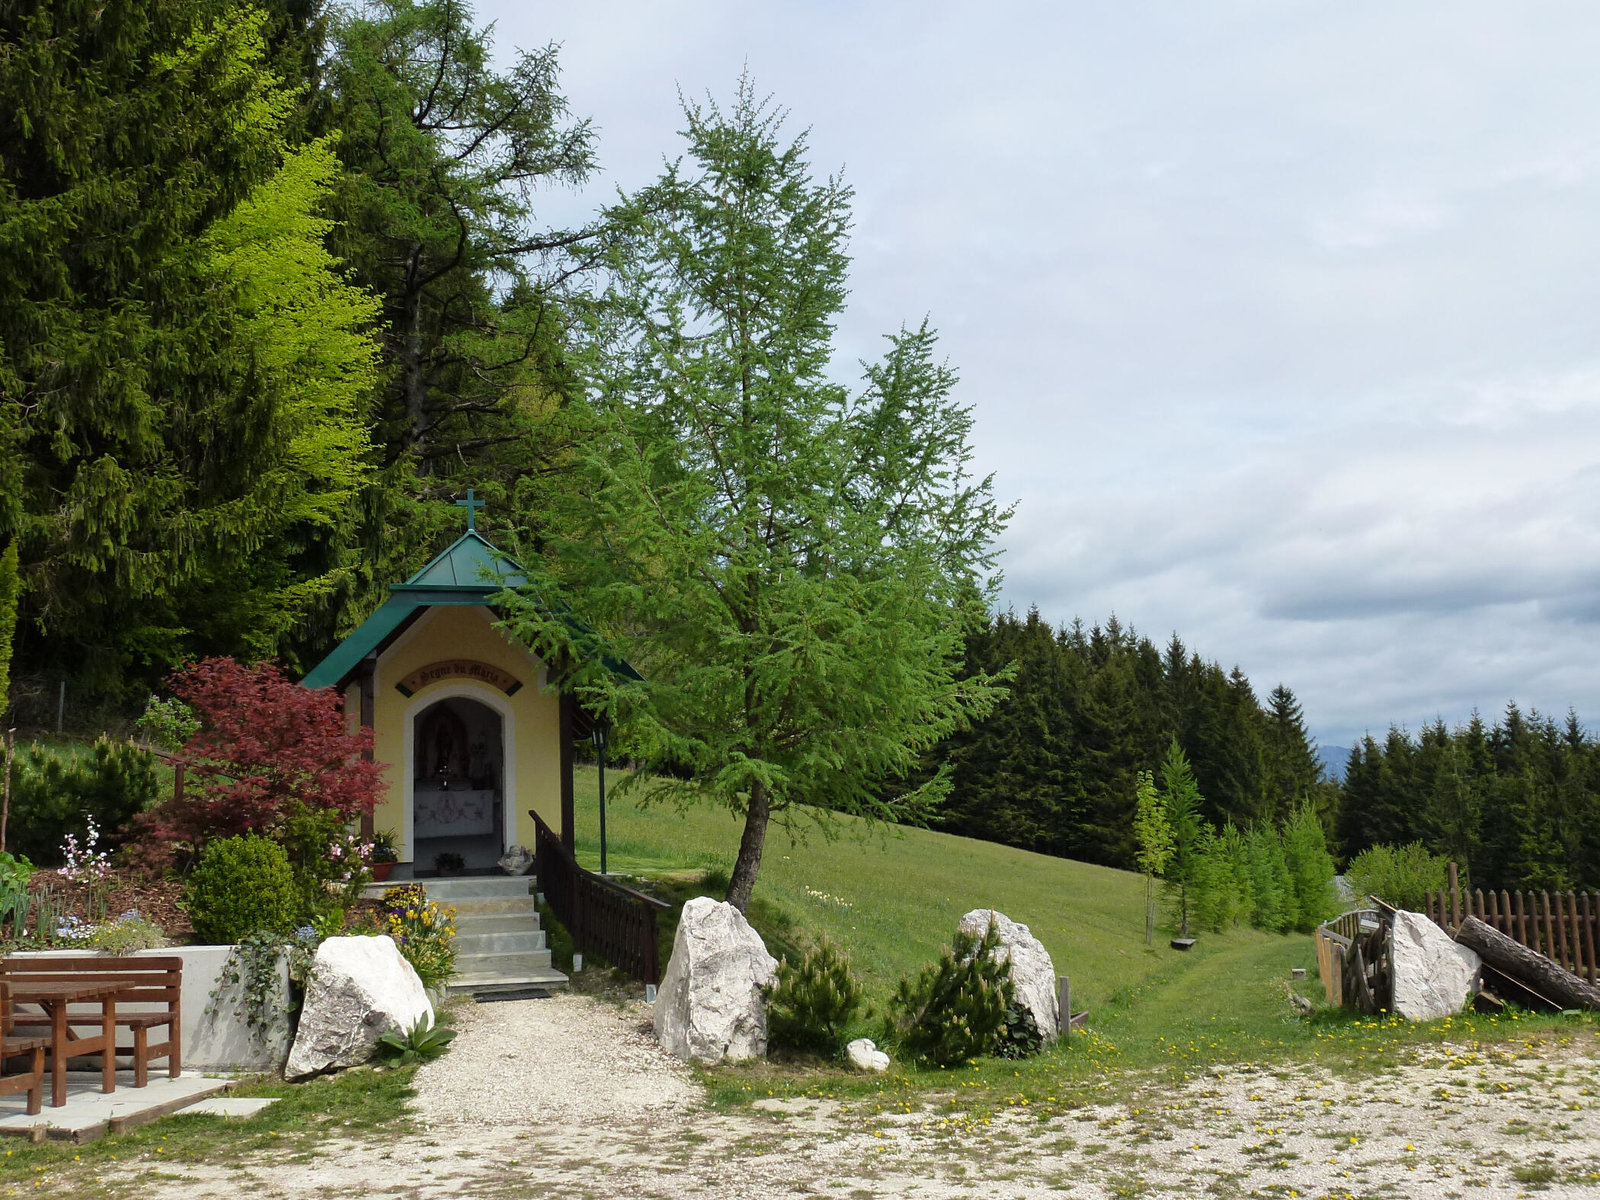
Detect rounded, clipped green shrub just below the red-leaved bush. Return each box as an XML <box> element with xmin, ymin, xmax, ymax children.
<box><xmin>184</xmin><ymin>834</ymin><xmax>301</xmax><ymax>944</ymax></box>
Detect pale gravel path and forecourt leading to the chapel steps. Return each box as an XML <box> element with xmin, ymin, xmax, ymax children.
<box><xmin>35</xmin><ymin>995</ymin><xmax>1600</xmax><ymax>1200</ymax></box>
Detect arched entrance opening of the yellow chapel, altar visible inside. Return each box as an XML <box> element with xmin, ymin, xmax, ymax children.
<box><xmin>411</xmin><ymin>694</ymin><xmax>506</xmax><ymax>875</ymax></box>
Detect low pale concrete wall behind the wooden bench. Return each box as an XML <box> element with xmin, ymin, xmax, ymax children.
<box><xmin>16</xmin><ymin>946</ymin><xmax>290</xmax><ymax>1072</ymax></box>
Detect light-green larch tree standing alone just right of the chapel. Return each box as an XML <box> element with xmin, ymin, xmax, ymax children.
<box><xmin>507</xmin><ymin>77</ymin><xmax>1008</xmax><ymax>909</ymax></box>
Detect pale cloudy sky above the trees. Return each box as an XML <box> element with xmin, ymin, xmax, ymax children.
<box><xmin>478</xmin><ymin>0</ymin><xmax>1600</xmax><ymax>746</ymax></box>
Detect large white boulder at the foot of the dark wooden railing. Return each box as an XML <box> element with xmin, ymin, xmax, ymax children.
<box><xmin>654</xmin><ymin>896</ymin><xmax>778</xmax><ymax>1062</ymax></box>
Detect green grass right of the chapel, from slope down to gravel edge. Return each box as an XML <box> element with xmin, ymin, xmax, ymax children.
<box><xmin>576</xmin><ymin>768</ymin><xmax>1595</xmax><ymax>1114</ymax></box>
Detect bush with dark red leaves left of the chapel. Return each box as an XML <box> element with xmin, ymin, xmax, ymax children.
<box><xmin>134</xmin><ymin>658</ymin><xmax>384</xmax><ymax>867</ymax></box>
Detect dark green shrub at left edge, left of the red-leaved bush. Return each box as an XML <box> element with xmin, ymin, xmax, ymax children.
<box><xmin>6</xmin><ymin>738</ymin><xmax>160</xmax><ymax>867</ymax></box>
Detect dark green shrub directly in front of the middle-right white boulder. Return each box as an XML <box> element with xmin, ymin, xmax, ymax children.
<box><xmin>885</xmin><ymin>925</ymin><xmax>1011</xmax><ymax>1067</ymax></box>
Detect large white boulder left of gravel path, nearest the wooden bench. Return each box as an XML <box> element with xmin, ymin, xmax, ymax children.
<box><xmin>283</xmin><ymin>934</ymin><xmax>434</xmax><ymax>1078</ymax></box>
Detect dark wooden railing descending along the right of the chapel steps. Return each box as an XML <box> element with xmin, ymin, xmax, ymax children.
<box><xmin>528</xmin><ymin>811</ymin><xmax>672</xmax><ymax>984</ymax></box>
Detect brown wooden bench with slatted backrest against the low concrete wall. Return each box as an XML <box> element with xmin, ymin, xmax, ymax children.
<box><xmin>0</xmin><ymin>954</ymin><xmax>184</xmax><ymax>1088</ymax></box>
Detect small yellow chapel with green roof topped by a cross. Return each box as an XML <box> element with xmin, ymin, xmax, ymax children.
<box><xmin>302</xmin><ymin>491</ymin><xmax>632</xmax><ymax>878</ymax></box>
